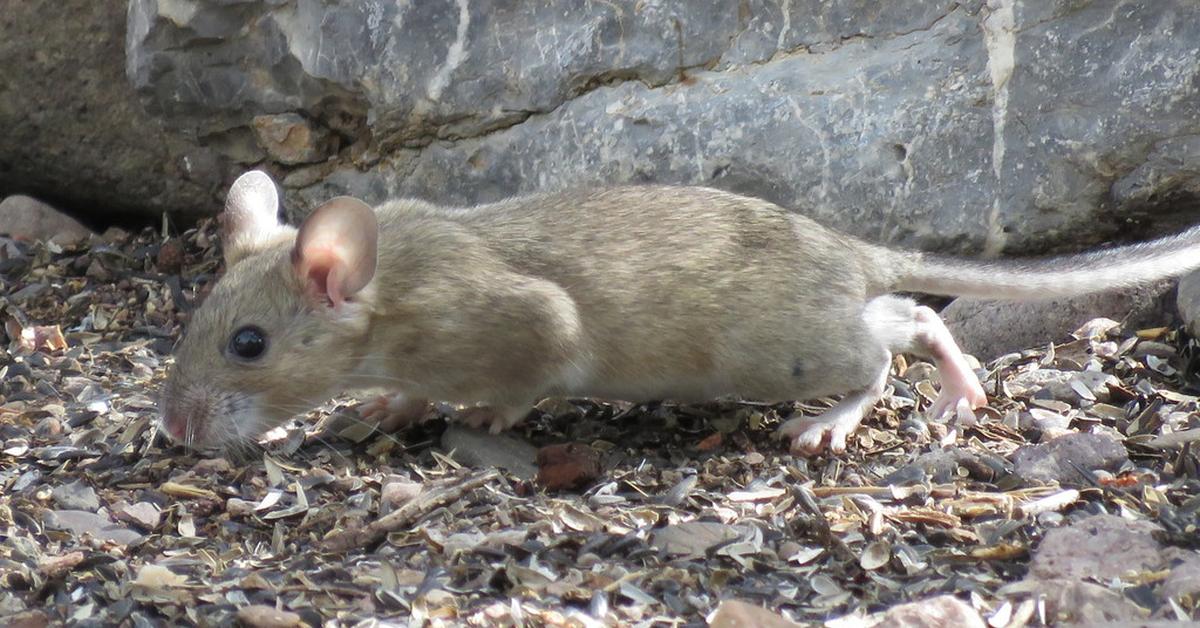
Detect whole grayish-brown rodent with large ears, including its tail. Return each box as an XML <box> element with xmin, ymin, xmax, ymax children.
<box><xmin>160</xmin><ymin>171</ymin><xmax>1200</xmax><ymax>455</ymax></box>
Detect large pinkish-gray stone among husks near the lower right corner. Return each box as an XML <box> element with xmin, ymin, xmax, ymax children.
<box><xmin>1030</xmin><ymin>515</ymin><xmax>1166</xmax><ymax>581</ymax></box>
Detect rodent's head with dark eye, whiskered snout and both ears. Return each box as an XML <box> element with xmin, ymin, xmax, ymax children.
<box><xmin>160</xmin><ymin>171</ymin><xmax>378</xmax><ymax>449</ymax></box>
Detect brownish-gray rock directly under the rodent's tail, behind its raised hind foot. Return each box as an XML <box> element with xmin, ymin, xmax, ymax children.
<box><xmin>941</xmin><ymin>281</ymin><xmax>1182</xmax><ymax>361</ymax></box>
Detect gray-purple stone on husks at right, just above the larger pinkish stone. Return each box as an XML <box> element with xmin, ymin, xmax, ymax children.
<box><xmin>1012</xmin><ymin>433</ymin><xmax>1129</xmax><ymax>485</ymax></box>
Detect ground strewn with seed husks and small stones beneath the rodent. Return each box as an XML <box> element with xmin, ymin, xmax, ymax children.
<box><xmin>0</xmin><ymin>223</ymin><xmax>1200</xmax><ymax>628</ymax></box>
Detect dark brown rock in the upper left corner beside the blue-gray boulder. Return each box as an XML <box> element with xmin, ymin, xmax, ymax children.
<box><xmin>0</xmin><ymin>0</ymin><xmax>220</xmax><ymax>223</ymax></box>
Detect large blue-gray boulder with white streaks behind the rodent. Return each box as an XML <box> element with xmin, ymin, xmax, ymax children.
<box><xmin>119</xmin><ymin>0</ymin><xmax>1200</xmax><ymax>255</ymax></box>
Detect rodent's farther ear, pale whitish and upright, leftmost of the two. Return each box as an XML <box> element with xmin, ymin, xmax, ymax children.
<box><xmin>220</xmin><ymin>171</ymin><xmax>281</xmax><ymax>267</ymax></box>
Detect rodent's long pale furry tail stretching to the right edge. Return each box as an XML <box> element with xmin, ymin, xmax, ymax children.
<box><xmin>894</xmin><ymin>227</ymin><xmax>1200</xmax><ymax>300</ymax></box>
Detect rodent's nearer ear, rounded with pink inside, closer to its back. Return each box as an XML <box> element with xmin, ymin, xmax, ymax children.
<box><xmin>292</xmin><ymin>196</ymin><xmax>379</xmax><ymax>307</ymax></box>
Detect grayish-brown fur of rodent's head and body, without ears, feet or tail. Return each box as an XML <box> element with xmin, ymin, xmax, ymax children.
<box><xmin>163</xmin><ymin>186</ymin><xmax>907</xmax><ymax>444</ymax></box>
